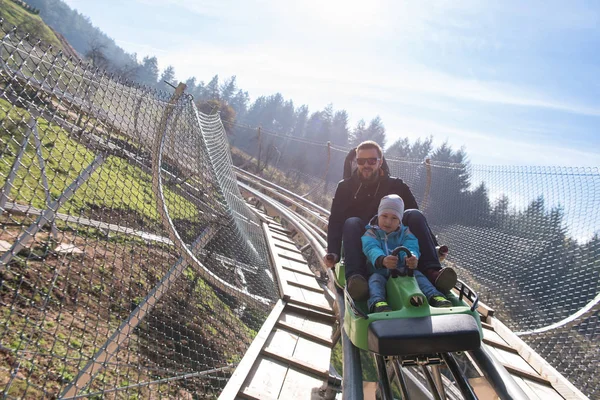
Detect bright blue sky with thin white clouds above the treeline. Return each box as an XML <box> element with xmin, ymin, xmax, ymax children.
<box><xmin>66</xmin><ymin>0</ymin><xmax>600</xmax><ymax>167</ymax></box>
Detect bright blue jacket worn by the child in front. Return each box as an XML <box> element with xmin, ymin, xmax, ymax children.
<box><xmin>361</xmin><ymin>216</ymin><xmax>421</xmax><ymax>273</ymax></box>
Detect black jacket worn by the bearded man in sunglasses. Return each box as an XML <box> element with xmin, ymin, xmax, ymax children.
<box><xmin>327</xmin><ymin>171</ymin><xmax>419</xmax><ymax>256</ymax></box>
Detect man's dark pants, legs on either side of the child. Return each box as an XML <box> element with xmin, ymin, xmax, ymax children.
<box><xmin>342</xmin><ymin>210</ymin><xmax>441</xmax><ymax>280</ymax></box>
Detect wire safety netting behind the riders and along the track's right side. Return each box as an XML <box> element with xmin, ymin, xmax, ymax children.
<box><xmin>232</xmin><ymin>126</ymin><xmax>600</xmax><ymax>398</ymax></box>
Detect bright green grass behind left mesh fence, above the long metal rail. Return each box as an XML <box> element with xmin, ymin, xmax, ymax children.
<box><xmin>0</xmin><ymin>95</ymin><xmax>199</xmax><ymax>224</ymax></box>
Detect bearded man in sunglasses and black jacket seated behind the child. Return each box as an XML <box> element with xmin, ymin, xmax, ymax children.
<box><xmin>324</xmin><ymin>140</ymin><xmax>456</xmax><ymax>300</ymax></box>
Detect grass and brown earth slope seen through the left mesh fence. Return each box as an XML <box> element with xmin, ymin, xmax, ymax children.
<box><xmin>0</xmin><ymin>94</ymin><xmax>265</xmax><ymax>399</ymax></box>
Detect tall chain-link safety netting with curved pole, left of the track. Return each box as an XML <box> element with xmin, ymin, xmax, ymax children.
<box><xmin>0</xmin><ymin>23</ymin><xmax>279</xmax><ymax>399</ymax></box>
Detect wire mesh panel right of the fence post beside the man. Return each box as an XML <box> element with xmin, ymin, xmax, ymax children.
<box><xmin>427</xmin><ymin>166</ymin><xmax>600</xmax><ymax>398</ymax></box>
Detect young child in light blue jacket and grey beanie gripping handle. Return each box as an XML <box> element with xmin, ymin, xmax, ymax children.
<box><xmin>362</xmin><ymin>194</ymin><xmax>452</xmax><ymax>312</ymax></box>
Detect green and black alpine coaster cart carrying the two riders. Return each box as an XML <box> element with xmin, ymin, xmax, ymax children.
<box><xmin>335</xmin><ymin>246</ymin><xmax>483</xmax><ymax>400</ymax></box>
